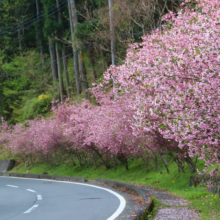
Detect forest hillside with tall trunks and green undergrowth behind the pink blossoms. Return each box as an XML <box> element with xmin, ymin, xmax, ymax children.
<box><xmin>0</xmin><ymin>0</ymin><xmax>181</xmax><ymax>124</ymax></box>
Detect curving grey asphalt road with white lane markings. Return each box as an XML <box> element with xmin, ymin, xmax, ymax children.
<box><xmin>0</xmin><ymin>177</ymin><xmax>126</xmax><ymax>220</ymax></box>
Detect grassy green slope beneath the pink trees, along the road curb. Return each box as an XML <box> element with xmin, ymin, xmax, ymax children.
<box><xmin>6</xmin><ymin>156</ymin><xmax>220</xmax><ymax>220</ymax></box>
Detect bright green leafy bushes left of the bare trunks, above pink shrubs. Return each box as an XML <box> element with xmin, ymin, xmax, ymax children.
<box><xmin>0</xmin><ymin>51</ymin><xmax>56</xmax><ymax>123</ymax></box>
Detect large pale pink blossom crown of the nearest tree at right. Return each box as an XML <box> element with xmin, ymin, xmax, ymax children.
<box><xmin>105</xmin><ymin>0</ymin><xmax>220</xmax><ymax>168</ymax></box>
